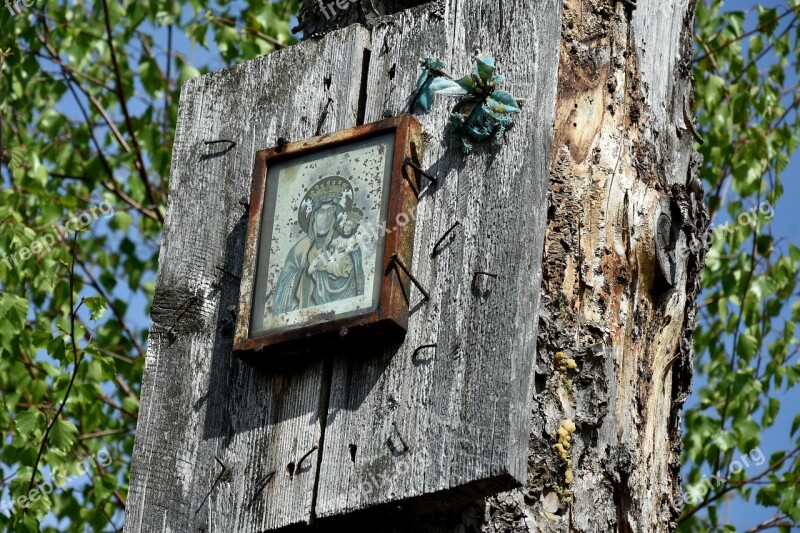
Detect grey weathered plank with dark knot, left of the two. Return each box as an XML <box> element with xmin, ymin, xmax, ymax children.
<box><xmin>125</xmin><ymin>27</ymin><xmax>368</xmax><ymax>532</ymax></box>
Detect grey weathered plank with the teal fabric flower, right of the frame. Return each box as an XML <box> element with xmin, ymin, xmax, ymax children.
<box><xmin>316</xmin><ymin>0</ymin><xmax>560</xmax><ymax>517</ymax></box>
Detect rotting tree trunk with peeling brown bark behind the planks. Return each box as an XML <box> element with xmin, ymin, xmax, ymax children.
<box><xmin>484</xmin><ymin>0</ymin><xmax>708</xmax><ymax>532</ymax></box>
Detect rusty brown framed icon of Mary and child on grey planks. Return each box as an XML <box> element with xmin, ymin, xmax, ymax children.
<box><xmin>234</xmin><ymin>115</ymin><xmax>422</xmax><ymax>357</ymax></box>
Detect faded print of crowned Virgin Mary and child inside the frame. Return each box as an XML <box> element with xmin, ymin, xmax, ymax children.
<box><xmin>245</xmin><ymin>133</ymin><xmax>395</xmax><ymax>336</ymax></box>
